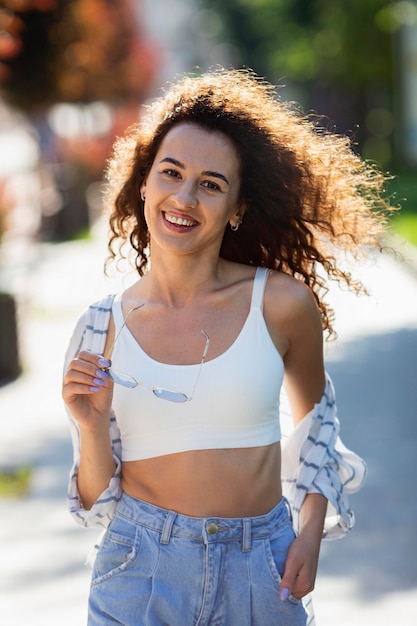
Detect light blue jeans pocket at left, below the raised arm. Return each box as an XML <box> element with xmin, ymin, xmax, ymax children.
<box><xmin>91</xmin><ymin>517</ymin><xmax>140</xmax><ymax>586</ymax></box>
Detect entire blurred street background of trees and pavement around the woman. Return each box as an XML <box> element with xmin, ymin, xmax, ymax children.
<box><xmin>0</xmin><ymin>0</ymin><xmax>417</xmax><ymax>626</ymax></box>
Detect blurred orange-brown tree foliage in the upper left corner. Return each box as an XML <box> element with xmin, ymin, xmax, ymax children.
<box><xmin>0</xmin><ymin>0</ymin><xmax>153</xmax><ymax>111</ymax></box>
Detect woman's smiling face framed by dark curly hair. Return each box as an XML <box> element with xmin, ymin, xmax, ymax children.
<box><xmin>141</xmin><ymin>123</ymin><xmax>244</xmax><ymax>260</ymax></box>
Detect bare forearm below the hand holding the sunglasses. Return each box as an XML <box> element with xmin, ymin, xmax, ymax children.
<box><xmin>77</xmin><ymin>428</ymin><xmax>116</xmax><ymax>510</ymax></box>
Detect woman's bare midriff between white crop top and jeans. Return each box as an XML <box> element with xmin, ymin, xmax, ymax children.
<box><xmin>122</xmin><ymin>442</ymin><xmax>282</xmax><ymax>517</ymax></box>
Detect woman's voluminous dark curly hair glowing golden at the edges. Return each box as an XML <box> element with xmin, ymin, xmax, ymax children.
<box><xmin>106</xmin><ymin>69</ymin><xmax>389</xmax><ymax>335</ymax></box>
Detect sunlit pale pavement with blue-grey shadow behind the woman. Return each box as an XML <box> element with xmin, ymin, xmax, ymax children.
<box><xmin>0</xmin><ymin>223</ymin><xmax>417</xmax><ymax>626</ymax></box>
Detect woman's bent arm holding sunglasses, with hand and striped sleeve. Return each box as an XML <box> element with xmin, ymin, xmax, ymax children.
<box><xmin>63</xmin><ymin>298</ymin><xmax>121</xmax><ymax>526</ymax></box>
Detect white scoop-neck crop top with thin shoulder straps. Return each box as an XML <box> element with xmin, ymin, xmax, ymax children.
<box><xmin>112</xmin><ymin>268</ymin><xmax>284</xmax><ymax>461</ymax></box>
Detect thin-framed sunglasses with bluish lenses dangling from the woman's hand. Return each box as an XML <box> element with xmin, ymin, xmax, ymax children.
<box><xmin>105</xmin><ymin>304</ymin><xmax>210</xmax><ymax>403</ymax></box>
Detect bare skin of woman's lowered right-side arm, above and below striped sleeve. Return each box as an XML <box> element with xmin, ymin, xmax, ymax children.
<box><xmin>266</xmin><ymin>277</ymin><xmax>327</xmax><ymax>599</ymax></box>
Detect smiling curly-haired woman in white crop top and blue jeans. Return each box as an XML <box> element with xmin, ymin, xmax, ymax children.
<box><xmin>63</xmin><ymin>70</ymin><xmax>384</xmax><ymax>626</ymax></box>
